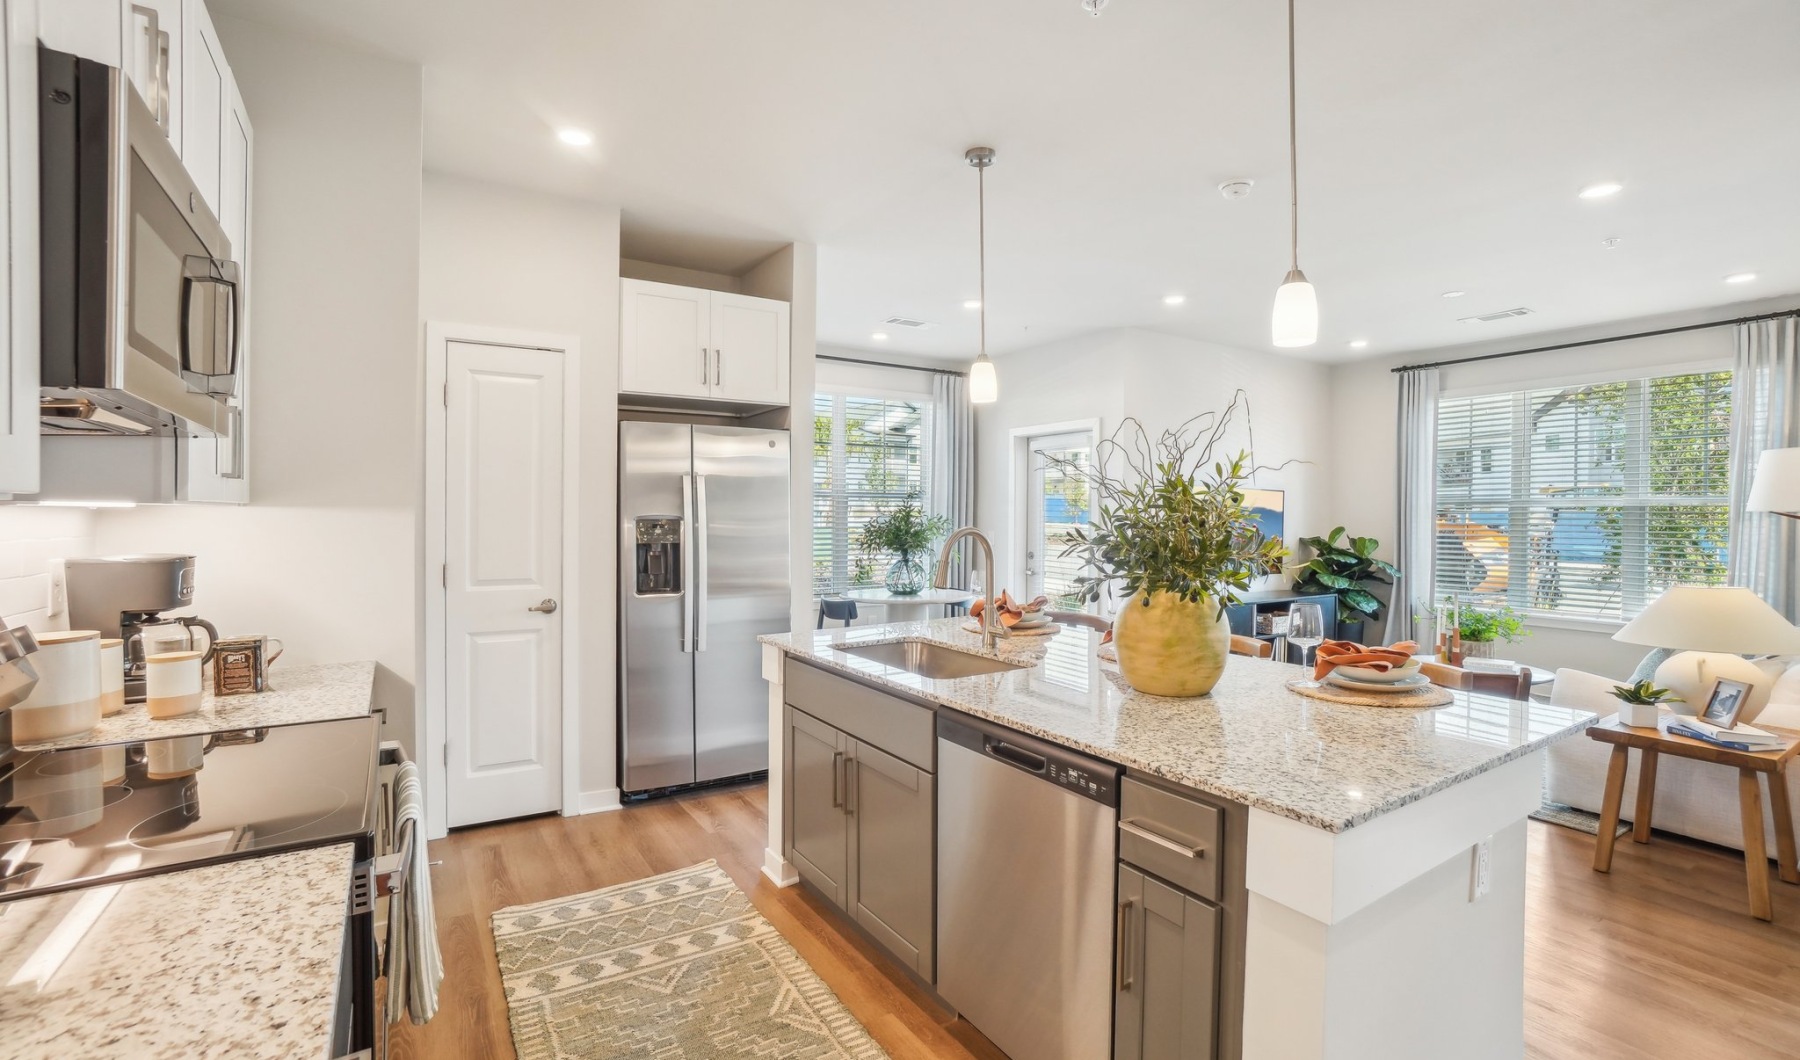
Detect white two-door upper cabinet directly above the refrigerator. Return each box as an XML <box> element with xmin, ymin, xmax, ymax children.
<box><xmin>619</xmin><ymin>279</ymin><xmax>788</xmax><ymax>405</ymax></box>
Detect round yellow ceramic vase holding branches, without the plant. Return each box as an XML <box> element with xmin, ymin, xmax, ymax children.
<box><xmin>1112</xmin><ymin>592</ymin><xmax>1231</xmax><ymax>696</ymax></box>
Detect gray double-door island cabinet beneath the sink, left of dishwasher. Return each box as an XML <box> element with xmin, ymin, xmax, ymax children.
<box><xmin>785</xmin><ymin>660</ymin><xmax>938</xmax><ymax>983</ymax></box>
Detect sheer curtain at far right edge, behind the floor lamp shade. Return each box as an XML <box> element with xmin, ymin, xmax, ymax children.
<box><xmin>1730</xmin><ymin>317</ymin><xmax>1800</xmax><ymax>623</ymax></box>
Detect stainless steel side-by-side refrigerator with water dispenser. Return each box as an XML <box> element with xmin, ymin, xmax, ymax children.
<box><xmin>619</xmin><ymin>421</ymin><xmax>788</xmax><ymax>795</ymax></box>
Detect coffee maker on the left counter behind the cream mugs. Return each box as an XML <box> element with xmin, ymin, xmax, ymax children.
<box><xmin>63</xmin><ymin>556</ymin><xmax>218</xmax><ymax>704</ymax></box>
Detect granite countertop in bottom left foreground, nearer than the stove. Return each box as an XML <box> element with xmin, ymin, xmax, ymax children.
<box><xmin>0</xmin><ymin>842</ymin><xmax>355</xmax><ymax>1060</ymax></box>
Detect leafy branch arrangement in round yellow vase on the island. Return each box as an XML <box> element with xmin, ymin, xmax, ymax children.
<box><xmin>1046</xmin><ymin>391</ymin><xmax>1287</xmax><ymax>696</ymax></box>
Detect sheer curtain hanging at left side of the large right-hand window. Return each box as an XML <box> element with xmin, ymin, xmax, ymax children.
<box><xmin>1388</xmin><ymin>369</ymin><xmax>1440</xmax><ymax>644</ymax></box>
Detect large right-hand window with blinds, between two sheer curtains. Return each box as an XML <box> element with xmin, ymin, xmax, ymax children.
<box><xmin>1435</xmin><ymin>371</ymin><xmax>1732</xmax><ymax>621</ymax></box>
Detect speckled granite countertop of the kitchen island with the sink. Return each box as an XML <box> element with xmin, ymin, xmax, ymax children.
<box><xmin>761</xmin><ymin>619</ymin><xmax>1595</xmax><ymax>831</ymax></box>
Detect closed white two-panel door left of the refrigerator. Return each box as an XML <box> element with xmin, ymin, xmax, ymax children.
<box><xmin>445</xmin><ymin>342</ymin><xmax>565</xmax><ymax>826</ymax></box>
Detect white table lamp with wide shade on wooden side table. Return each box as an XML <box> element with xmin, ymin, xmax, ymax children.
<box><xmin>1613</xmin><ymin>585</ymin><xmax>1800</xmax><ymax>722</ymax></box>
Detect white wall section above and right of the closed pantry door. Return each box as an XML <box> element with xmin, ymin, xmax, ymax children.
<box><xmin>418</xmin><ymin>173</ymin><xmax>619</xmax><ymax>806</ymax></box>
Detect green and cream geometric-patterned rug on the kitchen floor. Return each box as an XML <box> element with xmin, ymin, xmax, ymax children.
<box><xmin>493</xmin><ymin>862</ymin><xmax>887</xmax><ymax>1060</ymax></box>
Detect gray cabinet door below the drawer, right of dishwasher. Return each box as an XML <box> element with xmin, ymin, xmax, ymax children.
<box><xmin>1112</xmin><ymin>866</ymin><xmax>1219</xmax><ymax>1060</ymax></box>
